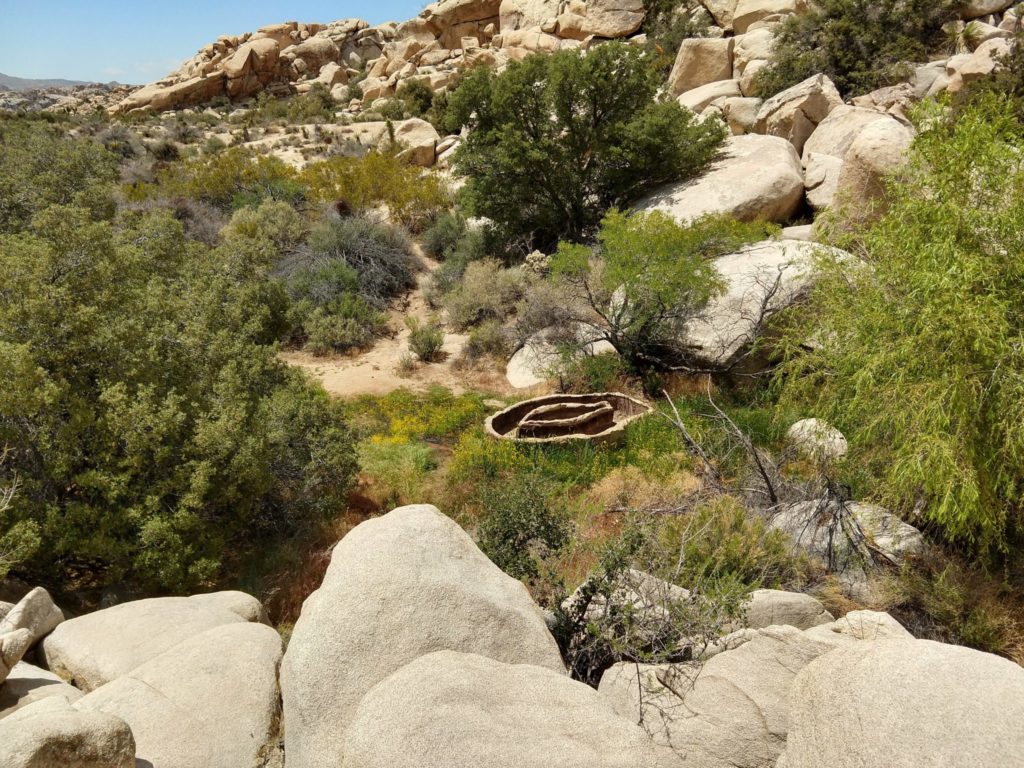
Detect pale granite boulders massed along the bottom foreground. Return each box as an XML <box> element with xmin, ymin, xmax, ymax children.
<box><xmin>6</xmin><ymin>505</ymin><xmax>1024</xmax><ymax>768</ymax></box>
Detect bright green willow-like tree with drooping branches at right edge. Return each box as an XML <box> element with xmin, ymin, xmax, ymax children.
<box><xmin>779</xmin><ymin>97</ymin><xmax>1024</xmax><ymax>550</ymax></box>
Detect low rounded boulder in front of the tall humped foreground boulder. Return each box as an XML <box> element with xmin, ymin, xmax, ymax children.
<box><xmin>340</xmin><ymin>651</ymin><xmax>658</xmax><ymax>768</ymax></box>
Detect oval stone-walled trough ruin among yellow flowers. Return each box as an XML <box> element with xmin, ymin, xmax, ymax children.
<box><xmin>485</xmin><ymin>392</ymin><xmax>653</xmax><ymax>443</ymax></box>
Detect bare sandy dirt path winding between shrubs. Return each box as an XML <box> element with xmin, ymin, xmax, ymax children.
<box><xmin>282</xmin><ymin>244</ymin><xmax>511</xmax><ymax>397</ymax></box>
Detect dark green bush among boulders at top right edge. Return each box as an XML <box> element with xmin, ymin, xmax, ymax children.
<box><xmin>757</xmin><ymin>0</ymin><xmax>959</xmax><ymax>97</ymax></box>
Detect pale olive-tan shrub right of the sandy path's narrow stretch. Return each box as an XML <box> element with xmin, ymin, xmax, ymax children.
<box><xmin>442</xmin><ymin>259</ymin><xmax>526</xmax><ymax>330</ymax></box>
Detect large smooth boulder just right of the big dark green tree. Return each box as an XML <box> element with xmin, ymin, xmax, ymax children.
<box><xmin>636</xmin><ymin>135</ymin><xmax>804</xmax><ymax>223</ymax></box>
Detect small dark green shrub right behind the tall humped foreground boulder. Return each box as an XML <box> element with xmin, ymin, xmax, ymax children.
<box><xmin>477</xmin><ymin>471</ymin><xmax>570</xmax><ymax>581</ymax></box>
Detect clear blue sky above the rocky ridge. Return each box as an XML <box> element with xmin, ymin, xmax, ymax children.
<box><xmin>0</xmin><ymin>0</ymin><xmax>426</xmax><ymax>83</ymax></box>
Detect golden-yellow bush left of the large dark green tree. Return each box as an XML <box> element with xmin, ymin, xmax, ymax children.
<box><xmin>299</xmin><ymin>152</ymin><xmax>447</xmax><ymax>231</ymax></box>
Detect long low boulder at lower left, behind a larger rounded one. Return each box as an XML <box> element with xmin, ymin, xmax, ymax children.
<box><xmin>40</xmin><ymin>592</ymin><xmax>262</xmax><ymax>691</ymax></box>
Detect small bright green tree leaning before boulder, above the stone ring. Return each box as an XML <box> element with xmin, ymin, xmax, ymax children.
<box><xmin>551</xmin><ymin>210</ymin><xmax>771</xmax><ymax>370</ymax></box>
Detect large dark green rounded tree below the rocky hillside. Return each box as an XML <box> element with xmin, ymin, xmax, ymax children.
<box><xmin>450</xmin><ymin>43</ymin><xmax>725</xmax><ymax>248</ymax></box>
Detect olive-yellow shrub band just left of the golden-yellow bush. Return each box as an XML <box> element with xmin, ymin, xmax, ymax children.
<box><xmin>147</xmin><ymin>146</ymin><xmax>306</xmax><ymax>211</ymax></box>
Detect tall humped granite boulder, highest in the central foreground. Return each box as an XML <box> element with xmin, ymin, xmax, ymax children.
<box><xmin>282</xmin><ymin>505</ymin><xmax>563</xmax><ymax>768</ymax></box>
